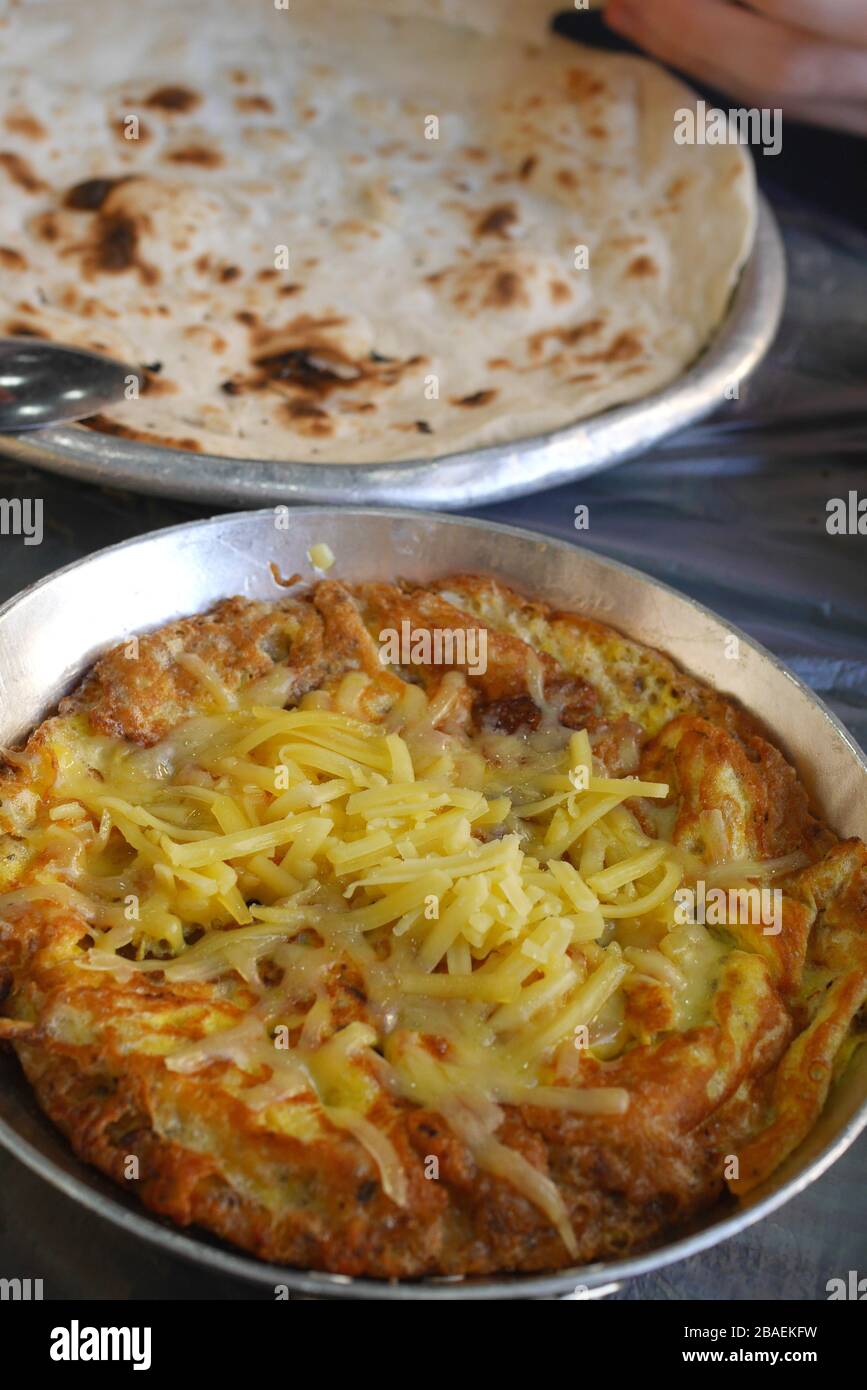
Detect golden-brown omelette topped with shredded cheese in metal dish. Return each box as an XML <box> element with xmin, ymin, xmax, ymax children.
<box><xmin>0</xmin><ymin>575</ymin><xmax>867</xmax><ymax>1279</ymax></box>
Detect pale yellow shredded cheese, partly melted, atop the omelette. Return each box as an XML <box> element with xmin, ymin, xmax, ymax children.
<box><xmin>6</xmin><ymin>672</ymin><xmax>743</xmax><ymax>1250</ymax></box>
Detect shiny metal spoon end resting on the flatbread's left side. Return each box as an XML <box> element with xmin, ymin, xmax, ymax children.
<box><xmin>0</xmin><ymin>338</ymin><xmax>134</xmax><ymax>432</ymax></box>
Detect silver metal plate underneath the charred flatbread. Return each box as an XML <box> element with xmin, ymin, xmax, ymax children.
<box><xmin>0</xmin><ymin>199</ymin><xmax>785</xmax><ymax>510</ymax></box>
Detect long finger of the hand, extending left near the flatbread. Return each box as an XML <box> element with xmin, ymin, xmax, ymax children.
<box><xmin>604</xmin><ymin>0</ymin><xmax>867</xmax><ymax>104</ymax></box>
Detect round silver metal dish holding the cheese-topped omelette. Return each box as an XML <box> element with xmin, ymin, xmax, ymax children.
<box><xmin>0</xmin><ymin>507</ymin><xmax>867</xmax><ymax>1300</ymax></box>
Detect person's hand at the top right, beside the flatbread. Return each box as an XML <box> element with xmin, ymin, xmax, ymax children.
<box><xmin>604</xmin><ymin>0</ymin><xmax>867</xmax><ymax>135</ymax></box>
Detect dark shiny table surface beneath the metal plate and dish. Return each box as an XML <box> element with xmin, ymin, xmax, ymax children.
<box><xmin>0</xmin><ymin>10</ymin><xmax>867</xmax><ymax>1300</ymax></box>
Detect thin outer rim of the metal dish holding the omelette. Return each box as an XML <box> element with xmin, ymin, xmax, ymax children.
<box><xmin>0</xmin><ymin>507</ymin><xmax>867</xmax><ymax>1301</ymax></box>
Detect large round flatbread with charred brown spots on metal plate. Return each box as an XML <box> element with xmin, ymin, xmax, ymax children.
<box><xmin>0</xmin><ymin>0</ymin><xmax>756</xmax><ymax>463</ymax></box>
